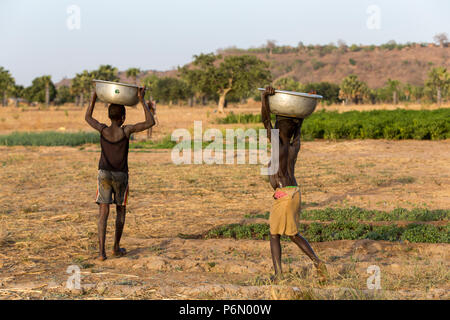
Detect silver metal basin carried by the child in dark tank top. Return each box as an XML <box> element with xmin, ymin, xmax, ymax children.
<box><xmin>93</xmin><ymin>80</ymin><xmax>139</xmax><ymax>106</ymax></box>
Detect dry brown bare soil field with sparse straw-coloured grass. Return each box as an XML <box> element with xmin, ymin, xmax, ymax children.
<box><xmin>0</xmin><ymin>106</ymin><xmax>450</xmax><ymax>299</ymax></box>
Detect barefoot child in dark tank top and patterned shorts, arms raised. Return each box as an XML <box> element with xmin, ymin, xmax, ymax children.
<box><xmin>85</xmin><ymin>88</ymin><xmax>155</xmax><ymax>261</ymax></box>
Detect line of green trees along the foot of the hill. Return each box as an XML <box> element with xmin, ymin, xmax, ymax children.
<box><xmin>0</xmin><ymin>53</ymin><xmax>450</xmax><ymax>112</ymax></box>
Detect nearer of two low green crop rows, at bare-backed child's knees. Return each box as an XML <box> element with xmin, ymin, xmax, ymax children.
<box><xmin>205</xmin><ymin>221</ymin><xmax>450</xmax><ymax>243</ymax></box>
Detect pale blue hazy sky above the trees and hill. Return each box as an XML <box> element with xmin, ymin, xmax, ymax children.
<box><xmin>0</xmin><ymin>0</ymin><xmax>450</xmax><ymax>85</ymax></box>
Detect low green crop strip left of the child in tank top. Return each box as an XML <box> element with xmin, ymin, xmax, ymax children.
<box><xmin>0</xmin><ymin>131</ymin><xmax>100</xmax><ymax>147</ymax></box>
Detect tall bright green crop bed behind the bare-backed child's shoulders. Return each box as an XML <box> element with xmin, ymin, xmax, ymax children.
<box><xmin>218</xmin><ymin>108</ymin><xmax>450</xmax><ymax>140</ymax></box>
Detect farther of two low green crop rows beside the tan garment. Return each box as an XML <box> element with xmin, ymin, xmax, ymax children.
<box><xmin>245</xmin><ymin>207</ymin><xmax>450</xmax><ymax>221</ymax></box>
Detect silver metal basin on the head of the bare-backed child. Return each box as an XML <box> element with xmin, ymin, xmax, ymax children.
<box><xmin>258</xmin><ymin>88</ymin><xmax>323</xmax><ymax>118</ymax></box>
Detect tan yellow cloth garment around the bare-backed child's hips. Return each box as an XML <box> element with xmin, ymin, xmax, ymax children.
<box><xmin>269</xmin><ymin>187</ymin><xmax>301</xmax><ymax>236</ymax></box>
